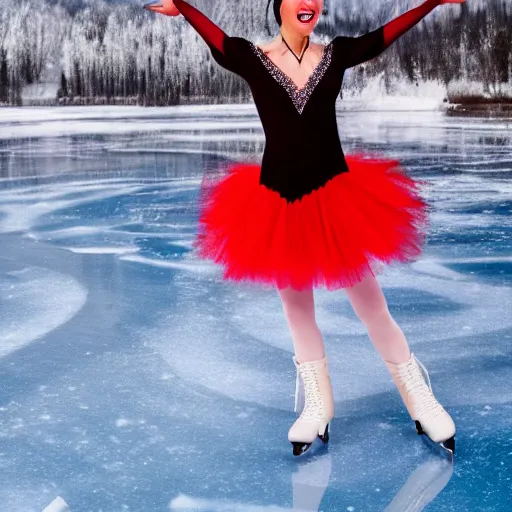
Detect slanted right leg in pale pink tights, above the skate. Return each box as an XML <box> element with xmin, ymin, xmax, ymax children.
<box><xmin>345</xmin><ymin>275</ymin><xmax>411</xmax><ymax>363</ymax></box>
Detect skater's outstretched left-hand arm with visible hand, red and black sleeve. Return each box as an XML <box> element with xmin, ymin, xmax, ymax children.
<box><xmin>144</xmin><ymin>0</ymin><xmax>240</xmax><ymax>71</ymax></box>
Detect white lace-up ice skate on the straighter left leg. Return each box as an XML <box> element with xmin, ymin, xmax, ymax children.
<box><xmin>288</xmin><ymin>356</ymin><xmax>334</xmax><ymax>455</ymax></box>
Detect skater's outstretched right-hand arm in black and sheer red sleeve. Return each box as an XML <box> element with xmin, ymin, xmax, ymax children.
<box><xmin>338</xmin><ymin>0</ymin><xmax>465</xmax><ymax>67</ymax></box>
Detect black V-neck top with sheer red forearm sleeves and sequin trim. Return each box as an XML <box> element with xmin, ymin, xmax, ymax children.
<box><xmin>163</xmin><ymin>0</ymin><xmax>440</xmax><ymax>201</ymax></box>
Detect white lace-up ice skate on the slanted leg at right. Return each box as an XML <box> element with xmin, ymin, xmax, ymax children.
<box><xmin>384</xmin><ymin>352</ymin><xmax>455</xmax><ymax>455</ymax></box>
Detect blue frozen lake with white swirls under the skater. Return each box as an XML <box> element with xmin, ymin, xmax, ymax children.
<box><xmin>0</xmin><ymin>105</ymin><xmax>512</xmax><ymax>512</ymax></box>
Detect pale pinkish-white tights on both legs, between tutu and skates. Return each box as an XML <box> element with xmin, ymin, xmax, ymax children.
<box><xmin>276</xmin><ymin>274</ymin><xmax>410</xmax><ymax>363</ymax></box>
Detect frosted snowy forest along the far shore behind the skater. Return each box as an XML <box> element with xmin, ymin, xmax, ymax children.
<box><xmin>0</xmin><ymin>0</ymin><xmax>512</xmax><ymax>106</ymax></box>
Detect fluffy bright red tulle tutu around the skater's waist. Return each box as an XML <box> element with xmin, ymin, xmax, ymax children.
<box><xmin>193</xmin><ymin>155</ymin><xmax>430</xmax><ymax>290</ymax></box>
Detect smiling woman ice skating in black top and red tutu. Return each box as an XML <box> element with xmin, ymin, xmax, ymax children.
<box><xmin>145</xmin><ymin>0</ymin><xmax>464</xmax><ymax>455</ymax></box>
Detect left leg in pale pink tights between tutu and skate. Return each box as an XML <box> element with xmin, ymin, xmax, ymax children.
<box><xmin>277</xmin><ymin>288</ymin><xmax>325</xmax><ymax>363</ymax></box>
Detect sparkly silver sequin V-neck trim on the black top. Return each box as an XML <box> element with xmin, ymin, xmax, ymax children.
<box><xmin>251</xmin><ymin>42</ymin><xmax>333</xmax><ymax>114</ymax></box>
